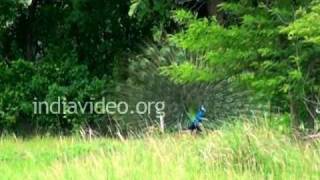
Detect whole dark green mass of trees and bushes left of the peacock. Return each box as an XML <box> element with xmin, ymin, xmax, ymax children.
<box><xmin>0</xmin><ymin>0</ymin><xmax>151</xmax><ymax>132</ymax></box>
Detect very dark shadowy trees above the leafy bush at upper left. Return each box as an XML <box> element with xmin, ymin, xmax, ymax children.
<box><xmin>0</xmin><ymin>0</ymin><xmax>150</xmax><ymax>78</ymax></box>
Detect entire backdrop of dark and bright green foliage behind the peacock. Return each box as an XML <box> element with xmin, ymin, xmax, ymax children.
<box><xmin>0</xmin><ymin>0</ymin><xmax>320</xmax><ymax>132</ymax></box>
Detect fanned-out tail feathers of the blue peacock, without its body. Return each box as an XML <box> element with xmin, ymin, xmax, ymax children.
<box><xmin>114</xmin><ymin>44</ymin><xmax>264</xmax><ymax>132</ymax></box>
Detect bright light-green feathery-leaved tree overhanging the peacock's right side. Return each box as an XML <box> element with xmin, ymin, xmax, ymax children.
<box><xmin>162</xmin><ymin>0</ymin><xmax>319</xmax><ymax>128</ymax></box>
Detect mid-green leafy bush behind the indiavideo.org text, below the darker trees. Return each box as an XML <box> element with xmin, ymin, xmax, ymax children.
<box><xmin>0</xmin><ymin>58</ymin><xmax>112</xmax><ymax>133</ymax></box>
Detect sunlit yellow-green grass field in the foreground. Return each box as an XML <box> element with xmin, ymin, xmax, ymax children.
<box><xmin>0</xmin><ymin>119</ymin><xmax>320</xmax><ymax>179</ymax></box>
